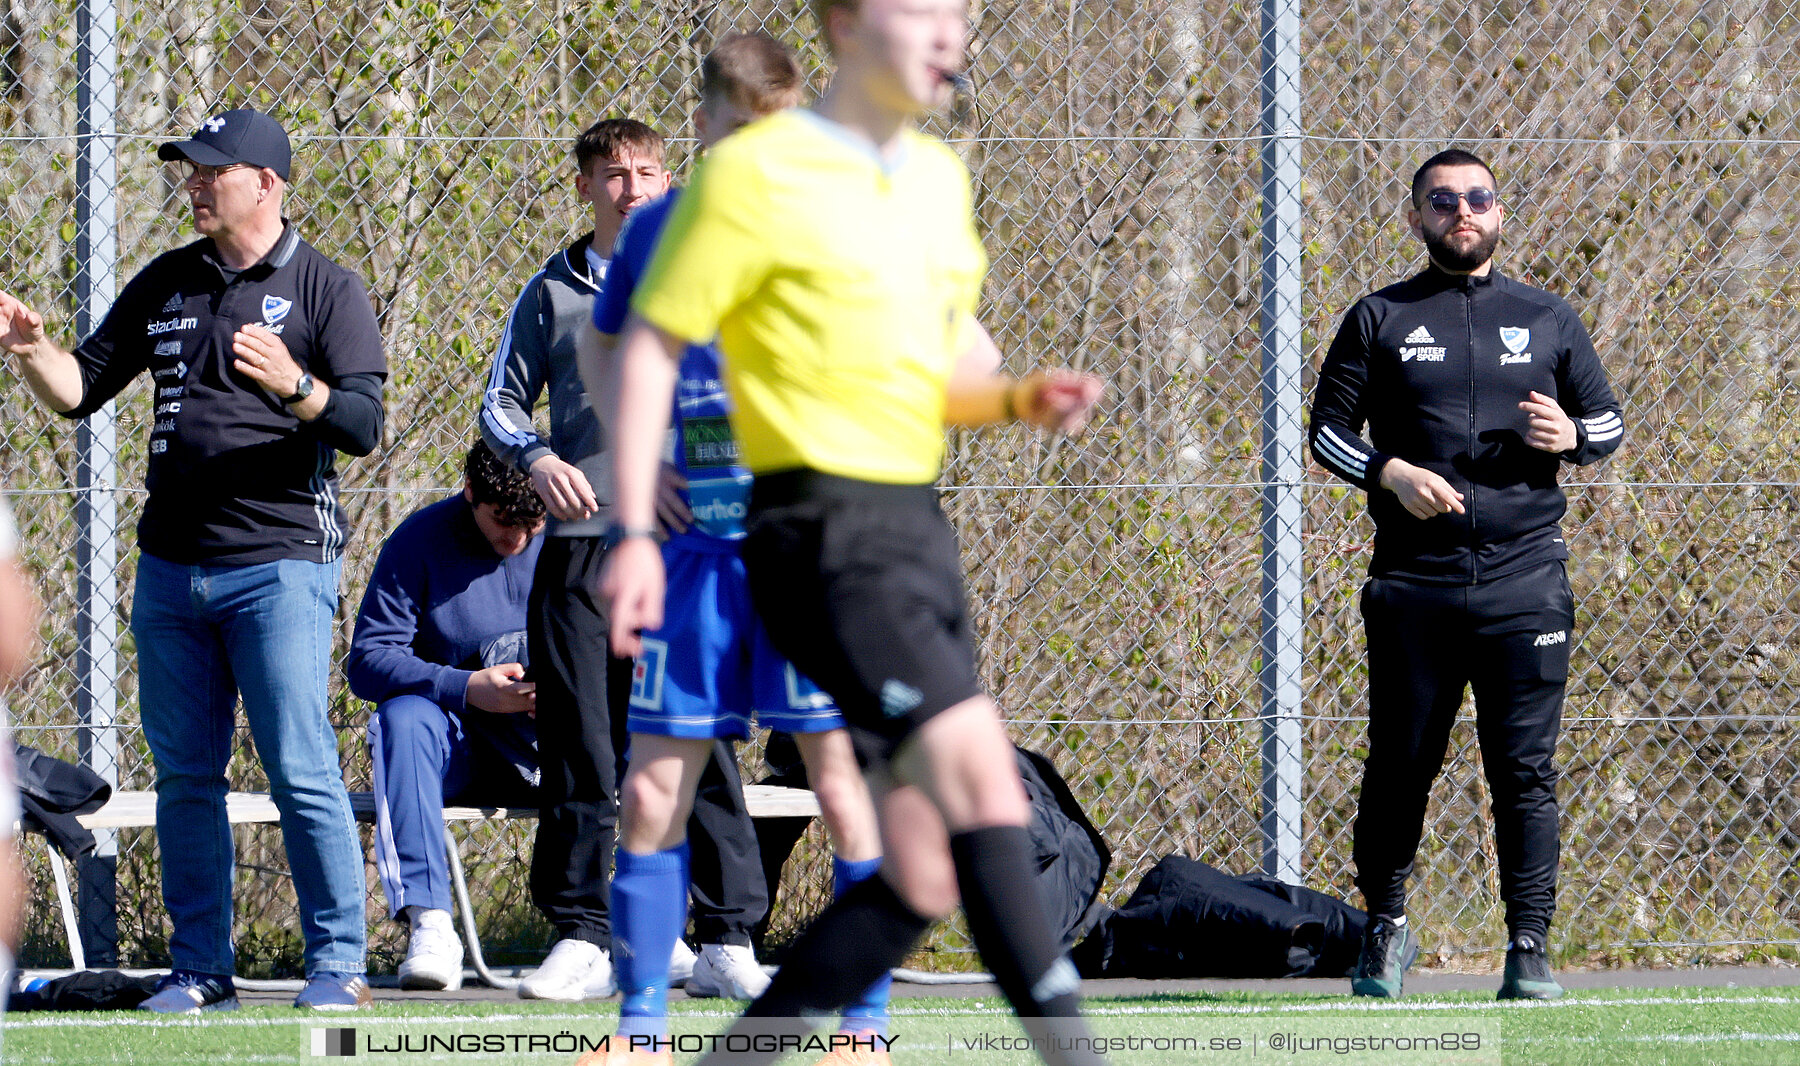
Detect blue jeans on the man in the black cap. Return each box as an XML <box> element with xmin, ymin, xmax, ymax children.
<box><xmin>131</xmin><ymin>553</ymin><xmax>367</xmax><ymax>976</ymax></box>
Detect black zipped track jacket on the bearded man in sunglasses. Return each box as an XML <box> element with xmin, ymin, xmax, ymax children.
<box><xmin>1309</xmin><ymin>267</ymin><xmax>1625</xmax><ymax>585</ymax></box>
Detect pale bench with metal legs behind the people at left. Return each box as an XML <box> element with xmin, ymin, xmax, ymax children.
<box><xmin>38</xmin><ymin>785</ymin><xmax>819</xmax><ymax>989</ymax></box>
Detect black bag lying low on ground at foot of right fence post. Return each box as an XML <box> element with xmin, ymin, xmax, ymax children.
<box><xmin>1075</xmin><ymin>855</ymin><xmax>1366</xmax><ymax>978</ymax></box>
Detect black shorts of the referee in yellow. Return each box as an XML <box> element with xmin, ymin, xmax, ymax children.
<box><xmin>743</xmin><ymin>470</ymin><xmax>981</xmax><ymax>763</ymax></box>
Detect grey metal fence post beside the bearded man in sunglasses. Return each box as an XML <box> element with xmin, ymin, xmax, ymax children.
<box><xmin>1262</xmin><ymin>0</ymin><xmax>1305</xmax><ymax>882</ymax></box>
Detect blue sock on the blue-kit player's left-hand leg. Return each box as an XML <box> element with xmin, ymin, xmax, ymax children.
<box><xmin>612</xmin><ymin>841</ymin><xmax>688</xmax><ymax>1035</ymax></box>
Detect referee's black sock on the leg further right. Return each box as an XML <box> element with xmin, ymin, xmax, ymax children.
<box><xmin>950</xmin><ymin>825</ymin><xmax>1105</xmax><ymax>1066</ymax></box>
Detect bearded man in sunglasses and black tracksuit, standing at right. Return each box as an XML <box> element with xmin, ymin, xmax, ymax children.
<box><xmin>1310</xmin><ymin>149</ymin><xmax>1625</xmax><ymax>999</ymax></box>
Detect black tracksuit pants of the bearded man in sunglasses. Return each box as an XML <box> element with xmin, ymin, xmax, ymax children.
<box><xmin>1354</xmin><ymin>560</ymin><xmax>1575</xmax><ymax>938</ymax></box>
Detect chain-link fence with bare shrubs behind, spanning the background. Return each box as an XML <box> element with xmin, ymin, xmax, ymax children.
<box><xmin>0</xmin><ymin>0</ymin><xmax>1800</xmax><ymax>972</ymax></box>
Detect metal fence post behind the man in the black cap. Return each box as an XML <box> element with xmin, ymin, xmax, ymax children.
<box><xmin>74</xmin><ymin>0</ymin><xmax>119</xmax><ymax>967</ymax></box>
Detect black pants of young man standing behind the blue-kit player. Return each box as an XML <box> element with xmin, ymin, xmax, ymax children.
<box><xmin>527</xmin><ymin>537</ymin><xmax>769</xmax><ymax>951</ymax></box>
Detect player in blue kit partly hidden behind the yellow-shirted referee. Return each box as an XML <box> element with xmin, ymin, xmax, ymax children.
<box><xmin>581</xmin><ymin>34</ymin><xmax>889</xmax><ymax>1064</ymax></box>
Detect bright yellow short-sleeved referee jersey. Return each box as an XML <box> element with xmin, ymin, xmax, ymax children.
<box><xmin>632</xmin><ymin>110</ymin><xmax>986</xmax><ymax>484</ymax></box>
